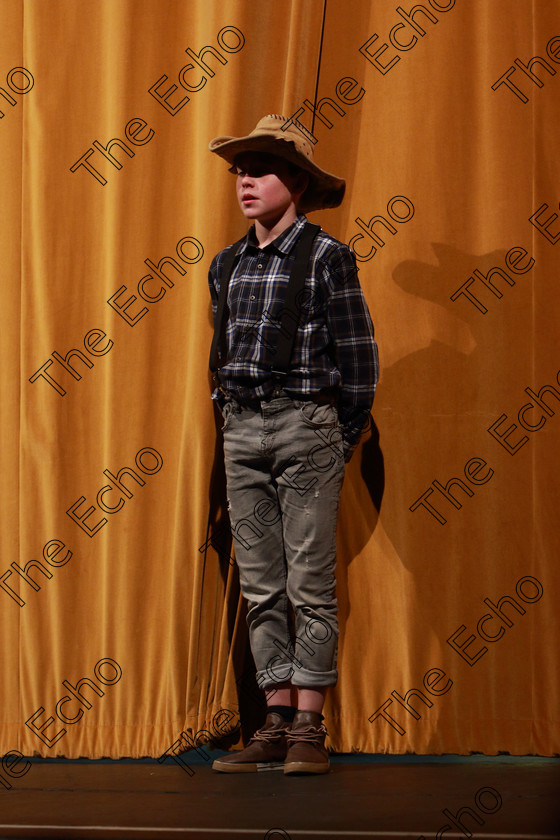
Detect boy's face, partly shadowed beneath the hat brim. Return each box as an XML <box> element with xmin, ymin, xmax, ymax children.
<box><xmin>233</xmin><ymin>152</ymin><xmax>308</xmax><ymax>222</ymax></box>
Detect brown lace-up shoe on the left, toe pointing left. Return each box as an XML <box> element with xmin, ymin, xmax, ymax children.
<box><xmin>212</xmin><ymin>712</ymin><xmax>291</xmax><ymax>773</ymax></box>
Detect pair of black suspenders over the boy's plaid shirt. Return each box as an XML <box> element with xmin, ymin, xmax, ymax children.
<box><xmin>210</xmin><ymin>222</ymin><xmax>321</xmax><ymax>383</ymax></box>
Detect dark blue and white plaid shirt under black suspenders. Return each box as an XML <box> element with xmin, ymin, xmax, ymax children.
<box><xmin>208</xmin><ymin>215</ymin><xmax>379</xmax><ymax>453</ymax></box>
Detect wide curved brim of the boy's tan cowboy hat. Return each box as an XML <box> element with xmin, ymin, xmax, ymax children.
<box><xmin>208</xmin><ymin>134</ymin><xmax>346</xmax><ymax>213</ymax></box>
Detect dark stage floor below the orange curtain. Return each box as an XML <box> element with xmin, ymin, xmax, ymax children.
<box><xmin>0</xmin><ymin>754</ymin><xmax>560</xmax><ymax>840</ymax></box>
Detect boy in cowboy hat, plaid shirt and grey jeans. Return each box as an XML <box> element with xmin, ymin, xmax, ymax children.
<box><xmin>209</xmin><ymin>114</ymin><xmax>378</xmax><ymax>774</ymax></box>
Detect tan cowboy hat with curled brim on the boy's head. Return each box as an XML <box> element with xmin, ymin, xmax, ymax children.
<box><xmin>208</xmin><ymin>114</ymin><xmax>346</xmax><ymax>213</ymax></box>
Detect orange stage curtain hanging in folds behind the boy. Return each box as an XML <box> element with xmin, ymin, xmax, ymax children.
<box><xmin>0</xmin><ymin>0</ymin><xmax>560</xmax><ymax>758</ymax></box>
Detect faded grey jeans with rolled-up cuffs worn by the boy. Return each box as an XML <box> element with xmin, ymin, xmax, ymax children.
<box><xmin>222</xmin><ymin>395</ymin><xmax>345</xmax><ymax>688</ymax></box>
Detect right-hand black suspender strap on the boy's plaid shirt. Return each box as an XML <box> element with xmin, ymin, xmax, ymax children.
<box><xmin>272</xmin><ymin>222</ymin><xmax>321</xmax><ymax>382</ymax></box>
